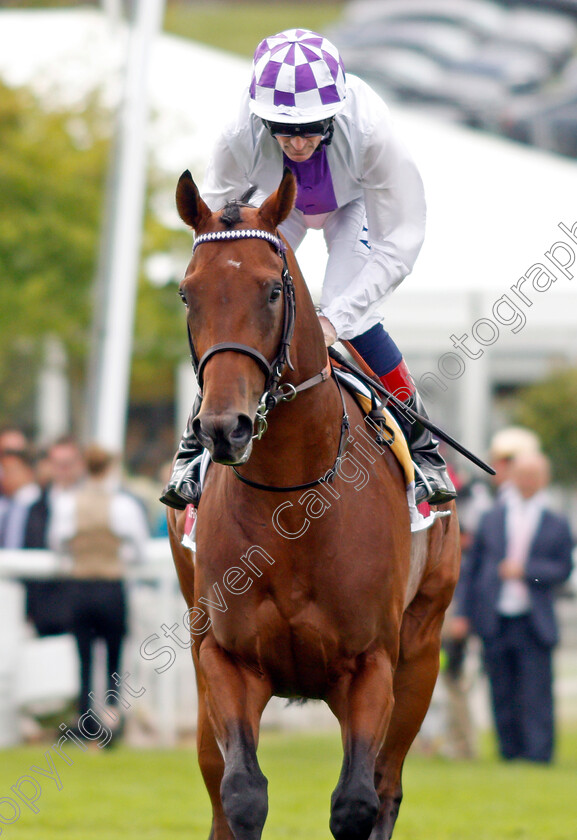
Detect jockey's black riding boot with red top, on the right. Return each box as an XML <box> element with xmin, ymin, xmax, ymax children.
<box><xmin>380</xmin><ymin>360</ymin><xmax>457</xmax><ymax>505</ymax></box>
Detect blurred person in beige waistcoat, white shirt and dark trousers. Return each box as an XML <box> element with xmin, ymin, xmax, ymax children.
<box><xmin>49</xmin><ymin>446</ymin><xmax>148</xmax><ymax>732</ymax></box>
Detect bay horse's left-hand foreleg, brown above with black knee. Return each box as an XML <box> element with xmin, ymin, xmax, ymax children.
<box><xmin>199</xmin><ymin>643</ymin><xmax>271</xmax><ymax>840</ymax></box>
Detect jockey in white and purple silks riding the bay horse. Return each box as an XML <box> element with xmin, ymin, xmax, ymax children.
<box><xmin>161</xmin><ymin>29</ymin><xmax>456</xmax><ymax>509</ymax></box>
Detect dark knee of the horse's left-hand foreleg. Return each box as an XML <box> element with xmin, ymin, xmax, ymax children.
<box><xmin>220</xmin><ymin>765</ymin><xmax>268</xmax><ymax>840</ymax></box>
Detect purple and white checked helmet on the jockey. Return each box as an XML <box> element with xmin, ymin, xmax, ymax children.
<box><xmin>249</xmin><ymin>29</ymin><xmax>347</xmax><ymax>124</ymax></box>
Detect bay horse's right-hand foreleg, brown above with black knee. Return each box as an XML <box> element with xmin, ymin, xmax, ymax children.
<box><xmin>328</xmin><ymin>652</ymin><xmax>393</xmax><ymax>840</ymax></box>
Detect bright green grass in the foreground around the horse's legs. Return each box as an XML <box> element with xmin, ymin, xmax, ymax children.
<box><xmin>0</xmin><ymin>730</ymin><xmax>577</xmax><ymax>840</ymax></box>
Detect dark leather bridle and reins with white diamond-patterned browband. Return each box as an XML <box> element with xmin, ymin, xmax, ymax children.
<box><xmin>188</xmin><ymin>228</ymin><xmax>349</xmax><ymax>492</ymax></box>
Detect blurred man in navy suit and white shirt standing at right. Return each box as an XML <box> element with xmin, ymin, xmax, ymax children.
<box><xmin>459</xmin><ymin>451</ymin><xmax>573</xmax><ymax>762</ymax></box>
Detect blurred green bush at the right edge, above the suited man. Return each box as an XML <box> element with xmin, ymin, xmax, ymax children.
<box><xmin>515</xmin><ymin>368</ymin><xmax>577</xmax><ymax>484</ymax></box>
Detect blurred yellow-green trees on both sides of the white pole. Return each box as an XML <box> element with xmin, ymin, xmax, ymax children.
<box><xmin>0</xmin><ymin>84</ymin><xmax>190</xmax><ymax>427</ymax></box>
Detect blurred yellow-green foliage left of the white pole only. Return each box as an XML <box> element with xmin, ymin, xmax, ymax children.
<box><xmin>0</xmin><ymin>81</ymin><xmax>108</xmax><ymax>420</ymax></box>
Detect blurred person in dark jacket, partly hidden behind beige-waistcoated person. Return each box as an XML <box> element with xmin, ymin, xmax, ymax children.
<box><xmin>23</xmin><ymin>437</ymin><xmax>86</xmax><ymax>636</ymax></box>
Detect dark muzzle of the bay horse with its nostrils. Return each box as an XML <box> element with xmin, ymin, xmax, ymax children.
<box><xmin>192</xmin><ymin>410</ymin><xmax>253</xmax><ymax>466</ymax></box>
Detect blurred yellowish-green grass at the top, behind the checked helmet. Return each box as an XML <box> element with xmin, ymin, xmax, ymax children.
<box><xmin>164</xmin><ymin>0</ymin><xmax>345</xmax><ymax>58</ymax></box>
